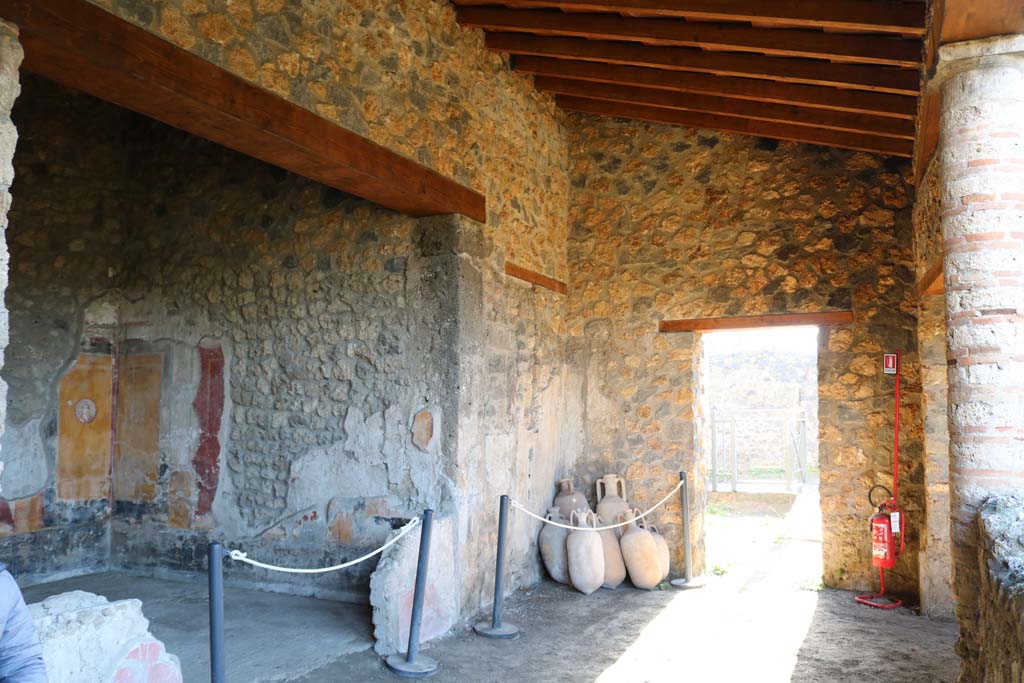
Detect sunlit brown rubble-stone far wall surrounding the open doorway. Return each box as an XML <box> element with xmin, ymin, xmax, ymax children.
<box><xmin>569</xmin><ymin>117</ymin><xmax>925</xmax><ymax>593</ymax></box>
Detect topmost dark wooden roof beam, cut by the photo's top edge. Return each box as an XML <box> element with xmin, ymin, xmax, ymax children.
<box><xmin>455</xmin><ymin>0</ymin><xmax>925</xmax><ymax>36</ymax></box>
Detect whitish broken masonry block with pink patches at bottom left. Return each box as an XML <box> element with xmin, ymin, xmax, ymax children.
<box><xmin>29</xmin><ymin>591</ymin><xmax>181</xmax><ymax>683</ymax></box>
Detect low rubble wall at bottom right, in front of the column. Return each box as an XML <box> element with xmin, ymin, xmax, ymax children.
<box><xmin>963</xmin><ymin>492</ymin><xmax>1024</xmax><ymax>683</ymax></box>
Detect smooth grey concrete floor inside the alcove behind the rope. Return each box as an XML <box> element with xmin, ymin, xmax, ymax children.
<box><xmin>24</xmin><ymin>573</ymin><xmax>374</xmax><ymax>683</ymax></box>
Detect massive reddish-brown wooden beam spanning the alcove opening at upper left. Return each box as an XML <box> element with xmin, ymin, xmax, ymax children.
<box><xmin>0</xmin><ymin>0</ymin><xmax>486</xmax><ymax>222</ymax></box>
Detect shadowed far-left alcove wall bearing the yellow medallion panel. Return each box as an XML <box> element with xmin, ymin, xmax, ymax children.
<box><xmin>0</xmin><ymin>76</ymin><xmax>142</xmax><ymax>581</ymax></box>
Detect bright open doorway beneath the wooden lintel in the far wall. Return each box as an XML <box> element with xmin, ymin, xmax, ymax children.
<box><xmin>702</xmin><ymin>326</ymin><xmax>821</xmax><ymax>590</ymax></box>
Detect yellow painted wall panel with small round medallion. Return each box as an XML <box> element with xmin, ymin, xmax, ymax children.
<box><xmin>57</xmin><ymin>354</ymin><xmax>114</xmax><ymax>501</ymax></box>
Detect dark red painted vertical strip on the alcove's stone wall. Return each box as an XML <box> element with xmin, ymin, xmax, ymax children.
<box><xmin>193</xmin><ymin>346</ymin><xmax>224</xmax><ymax>515</ymax></box>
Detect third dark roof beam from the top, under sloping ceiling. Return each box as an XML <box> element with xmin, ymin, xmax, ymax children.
<box><xmin>484</xmin><ymin>33</ymin><xmax>921</xmax><ymax>95</ymax></box>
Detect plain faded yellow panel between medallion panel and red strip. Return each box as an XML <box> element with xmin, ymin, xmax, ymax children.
<box><xmin>114</xmin><ymin>354</ymin><xmax>163</xmax><ymax>503</ymax></box>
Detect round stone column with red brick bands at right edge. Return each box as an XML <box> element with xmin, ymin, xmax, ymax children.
<box><xmin>932</xmin><ymin>36</ymin><xmax>1024</xmax><ymax>681</ymax></box>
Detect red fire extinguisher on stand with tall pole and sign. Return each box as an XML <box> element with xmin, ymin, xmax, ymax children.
<box><xmin>854</xmin><ymin>351</ymin><xmax>906</xmax><ymax>609</ymax></box>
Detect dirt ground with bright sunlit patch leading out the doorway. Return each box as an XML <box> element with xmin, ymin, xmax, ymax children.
<box><xmin>296</xmin><ymin>489</ymin><xmax>958</xmax><ymax>683</ymax></box>
